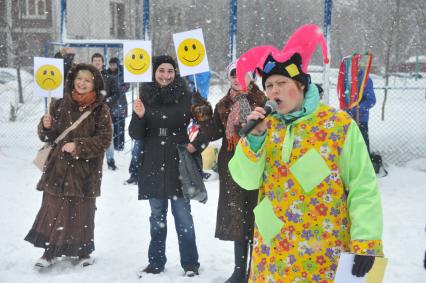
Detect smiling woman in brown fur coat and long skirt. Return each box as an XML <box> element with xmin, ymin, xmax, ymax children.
<box><xmin>25</xmin><ymin>64</ymin><xmax>112</xmax><ymax>268</ymax></box>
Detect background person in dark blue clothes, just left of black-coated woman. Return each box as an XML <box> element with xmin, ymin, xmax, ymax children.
<box><xmin>107</xmin><ymin>57</ymin><xmax>130</xmax><ymax>151</ymax></box>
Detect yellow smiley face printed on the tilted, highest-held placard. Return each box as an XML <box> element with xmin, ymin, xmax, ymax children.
<box><xmin>177</xmin><ymin>38</ymin><xmax>206</xmax><ymax>67</ymax></box>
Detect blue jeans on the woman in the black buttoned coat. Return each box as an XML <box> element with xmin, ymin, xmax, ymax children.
<box><xmin>148</xmin><ymin>198</ymin><xmax>200</xmax><ymax>271</ymax></box>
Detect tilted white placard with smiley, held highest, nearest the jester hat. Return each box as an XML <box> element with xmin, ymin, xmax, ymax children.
<box><xmin>173</xmin><ymin>29</ymin><xmax>210</xmax><ymax>76</ymax></box>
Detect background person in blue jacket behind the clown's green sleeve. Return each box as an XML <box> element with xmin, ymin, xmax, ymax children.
<box><xmin>348</xmin><ymin>69</ymin><xmax>376</xmax><ymax>153</ymax></box>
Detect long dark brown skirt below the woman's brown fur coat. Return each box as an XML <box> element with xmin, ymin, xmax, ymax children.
<box><xmin>25</xmin><ymin>193</ymin><xmax>96</xmax><ymax>258</ymax></box>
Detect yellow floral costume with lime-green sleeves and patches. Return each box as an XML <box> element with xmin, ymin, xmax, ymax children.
<box><xmin>228</xmin><ymin>85</ymin><xmax>383</xmax><ymax>283</ymax></box>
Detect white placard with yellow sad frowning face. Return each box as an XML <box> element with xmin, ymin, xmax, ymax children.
<box><xmin>33</xmin><ymin>57</ymin><xmax>65</xmax><ymax>98</ymax></box>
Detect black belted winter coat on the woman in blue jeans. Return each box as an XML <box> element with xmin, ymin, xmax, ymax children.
<box><xmin>129</xmin><ymin>76</ymin><xmax>205</xmax><ymax>199</ymax></box>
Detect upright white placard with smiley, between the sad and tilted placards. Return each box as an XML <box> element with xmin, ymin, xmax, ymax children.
<box><xmin>123</xmin><ymin>40</ymin><xmax>152</xmax><ymax>83</ymax></box>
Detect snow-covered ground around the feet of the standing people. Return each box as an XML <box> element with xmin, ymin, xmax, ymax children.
<box><xmin>0</xmin><ymin>122</ymin><xmax>426</xmax><ymax>283</ymax></box>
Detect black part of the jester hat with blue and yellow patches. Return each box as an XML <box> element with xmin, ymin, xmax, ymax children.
<box><xmin>258</xmin><ymin>53</ymin><xmax>311</xmax><ymax>91</ymax></box>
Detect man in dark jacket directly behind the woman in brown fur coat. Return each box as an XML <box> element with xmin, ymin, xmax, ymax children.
<box><xmin>91</xmin><ymin>53</ymin><xmax>120</xmax><ymax>171</ymax></box>
